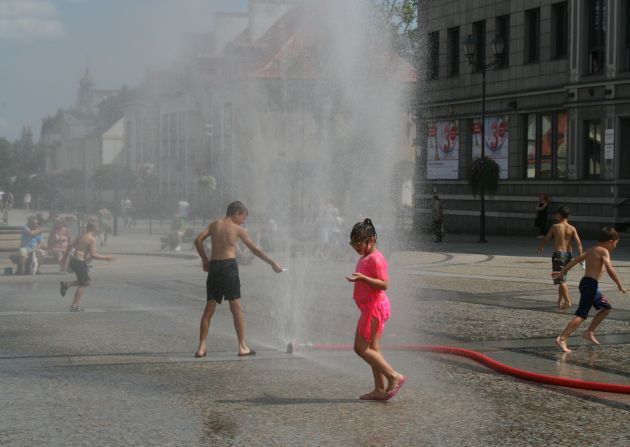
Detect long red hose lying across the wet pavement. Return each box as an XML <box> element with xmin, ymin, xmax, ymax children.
<box><xmin>309</xmin><ymin>344</ymin><xmax>630</xmax><ymax>394</ymax></box>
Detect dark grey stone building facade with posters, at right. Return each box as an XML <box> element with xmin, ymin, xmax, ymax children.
<box><xmin>415</xmin><ymin>0</ymin><xmax>630</xmax><ymax>237</ymax></box>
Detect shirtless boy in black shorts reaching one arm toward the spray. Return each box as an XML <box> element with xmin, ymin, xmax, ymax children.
<box><xmin>195</xmin><ymin>201</ymin><xmax>283</xmax><ymax>357</ymax></box>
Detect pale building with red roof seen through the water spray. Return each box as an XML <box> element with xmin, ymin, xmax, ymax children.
<box><xmin>124</xmin><ymin>0</ymin><xmax>416</xmax><ymax>223</ymax></box>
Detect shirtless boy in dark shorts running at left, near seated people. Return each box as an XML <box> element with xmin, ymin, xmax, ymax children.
<box><xmin>59</xmin><ymin>220</ymin><xmax>114</xmax><ymax>312</ymax></box>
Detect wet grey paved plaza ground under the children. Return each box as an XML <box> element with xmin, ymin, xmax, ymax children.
<box><xmin>0</xmin><ymin>211</ymin><xmax>630</xmax><ymax>447</ymax></box>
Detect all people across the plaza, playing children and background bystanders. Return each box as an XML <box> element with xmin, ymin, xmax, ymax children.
<box><xmin>3</xmin><ymin>194</ymin><xmax>626</xmax><ymax>400</ymax></box>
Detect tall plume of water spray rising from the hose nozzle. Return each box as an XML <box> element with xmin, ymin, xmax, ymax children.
<box><xmin>240</xmin><ymin>0</ymin><xmax>415</xmax><ymax>349</ymax></box>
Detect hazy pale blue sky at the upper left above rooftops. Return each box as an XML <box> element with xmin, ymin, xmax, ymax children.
<box><xmin>0</xmin><ymin>0</ymin><xmax>247</xmax><ymax>141</ymax></box>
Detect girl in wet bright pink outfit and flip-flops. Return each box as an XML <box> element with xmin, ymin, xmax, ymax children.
<box><xmin>346</xmin><ymin>219</ymin><xmax>407</xmax><ymax>400</ymax></box>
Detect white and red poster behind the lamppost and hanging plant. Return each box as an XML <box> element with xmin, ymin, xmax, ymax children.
<box><xmin>472</xmin><ymin>116</ymin><xmax>509</xmax><ymax>179</ymax></box>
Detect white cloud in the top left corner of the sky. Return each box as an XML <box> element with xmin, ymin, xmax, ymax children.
<box><xmin>0</xmin><ymin>0</ymin><xmax>66</xmax><ymax>41</ymax></box>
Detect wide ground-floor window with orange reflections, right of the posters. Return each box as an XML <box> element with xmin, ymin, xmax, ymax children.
<box><xmin>524</xmin><ymin>112</ymin><xmax>567</xmax><ymax>179</ymax></box>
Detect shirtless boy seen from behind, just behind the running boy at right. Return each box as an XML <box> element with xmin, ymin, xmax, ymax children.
<box><xmin>538</xmin><ymin>206</ymin><xmax>582</xmax><ymax>310</ymax></box>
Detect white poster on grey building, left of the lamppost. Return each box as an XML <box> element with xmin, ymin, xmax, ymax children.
<box><xmin>427</xmin><ymin>121</ymin><xmax>459</xmax><ymax>180</ymax></box>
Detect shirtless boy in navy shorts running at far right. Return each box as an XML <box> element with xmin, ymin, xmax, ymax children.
<box><xmin>551</xmin><ymin>227</ymin><xmax>626</xmax><ymax>352</ymax></box>
